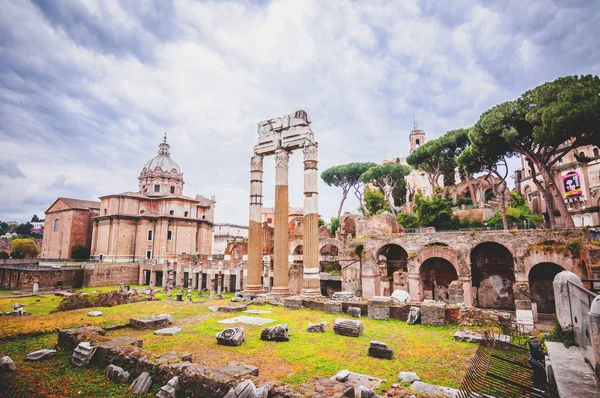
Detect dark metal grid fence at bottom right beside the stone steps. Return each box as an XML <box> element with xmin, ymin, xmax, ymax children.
<box><xmin>458</xmin><ymin>333</ymin><xmax>555</xmax><ymax>398</ymax></box>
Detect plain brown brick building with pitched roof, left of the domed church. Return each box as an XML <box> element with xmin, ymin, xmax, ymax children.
<box><xmin>40</xmin><ymin>198</ymin><xmax>100</xmax><ymax>259</ymax></box>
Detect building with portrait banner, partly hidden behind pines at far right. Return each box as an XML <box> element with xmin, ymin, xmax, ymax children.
<box><xmin>514</xmin><ymin>145</ymin><xmax>600</xmax><ymax>227</ymax></box>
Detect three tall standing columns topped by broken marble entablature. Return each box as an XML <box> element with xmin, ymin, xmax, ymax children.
<box><xmin>245</xmin><ymin>110</ymin><xmax>321</xmax><ymax>297</ymax></box>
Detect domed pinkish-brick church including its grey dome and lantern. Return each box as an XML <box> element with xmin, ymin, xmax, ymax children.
<box><xmin>91</xmin><ymin>135</ymin><xmax>215</xmax><ymax>264</ymax></box>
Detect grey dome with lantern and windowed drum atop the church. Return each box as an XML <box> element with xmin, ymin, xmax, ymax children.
<box><xmin>138</xmin><ymin>133</ymin><xmax>183</xmax><ymax>195</ymax></box>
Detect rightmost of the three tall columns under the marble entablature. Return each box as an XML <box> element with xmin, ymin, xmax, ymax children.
<box><xmin>300</xmin><ymin>143</ymin><xmax>321</xmax><ymax>297</ymax></box>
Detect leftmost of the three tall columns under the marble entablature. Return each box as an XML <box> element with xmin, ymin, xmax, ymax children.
<box><xmin>244</xmin><ymin>155</ymin><xmax>264</xmax><ymax>295</ymax></box>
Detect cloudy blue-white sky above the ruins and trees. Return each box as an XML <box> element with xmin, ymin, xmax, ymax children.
<box><xmin>0</xmin><ymin>0</ymin><xmax>600</xmax><ymax>225</ymax></box>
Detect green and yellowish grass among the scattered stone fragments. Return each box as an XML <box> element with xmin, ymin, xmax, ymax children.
<box><xmin>0</xmin><ymin>288</ymin><xmax>477</xmax><ymax>396</ymax></box>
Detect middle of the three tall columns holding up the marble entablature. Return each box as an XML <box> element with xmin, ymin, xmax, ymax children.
<box><xmin>271</xmin><ymin>149</ymin><xmax>290</xmax><ymax>297</ymax></box>
